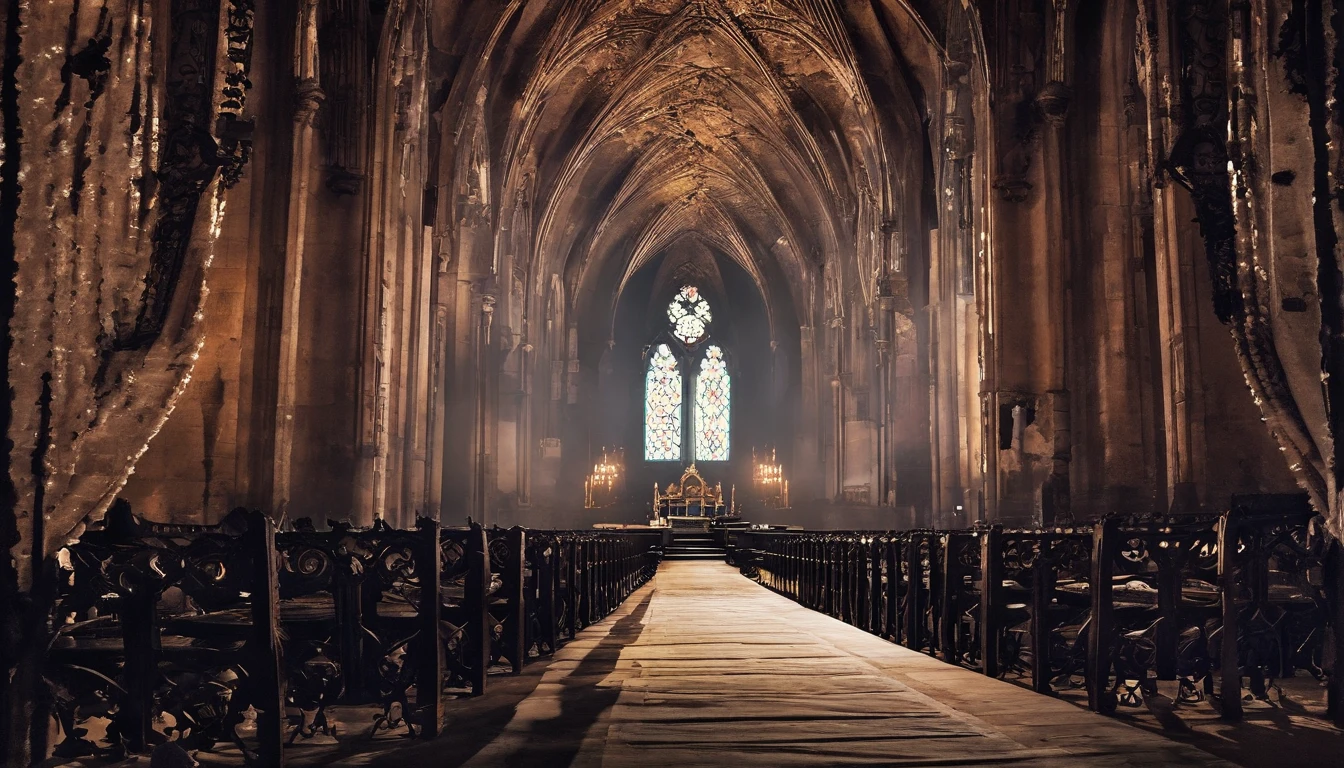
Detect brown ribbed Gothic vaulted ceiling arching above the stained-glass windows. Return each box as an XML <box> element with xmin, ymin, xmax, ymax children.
<box><xmin>431</xmin><ymin>0</ymin><xmax>967</xmax><ymax>336</ymax></box>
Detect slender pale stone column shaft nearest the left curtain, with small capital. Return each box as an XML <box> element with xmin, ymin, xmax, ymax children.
<box><xmin>270</xmin><ymin>0</ymin><xmax>324</xmax><ymax>519</ymax></box>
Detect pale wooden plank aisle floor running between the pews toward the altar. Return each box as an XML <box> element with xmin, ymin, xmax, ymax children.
<box><xmin>443</xmin><ymin>561</ymin><xmax>1231</xmax><ymax>768</ymax></box>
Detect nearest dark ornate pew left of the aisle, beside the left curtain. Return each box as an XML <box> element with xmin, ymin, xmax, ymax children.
<box><xmin>47</xmin><ymin>512</ymin><xmax>285</xmax><ymax>765</ymax></box>
